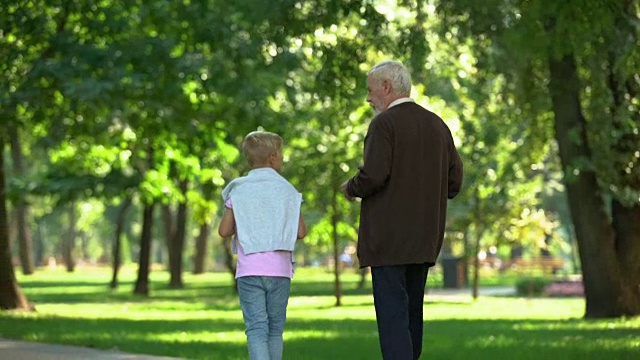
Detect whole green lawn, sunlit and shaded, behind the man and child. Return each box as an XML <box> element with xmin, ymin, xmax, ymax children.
<box><xmin>8</xmin><ymin>268</ymin><xmax>640</xmax><ymax>360</ymax></box>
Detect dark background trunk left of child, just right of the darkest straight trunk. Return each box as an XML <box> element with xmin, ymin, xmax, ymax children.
<box><xmin>169</xmin><ymin>180</ymin><xmax>189</xmax><ymax>289</ymax></box>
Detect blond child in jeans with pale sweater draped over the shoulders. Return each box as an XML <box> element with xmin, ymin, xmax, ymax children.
<box><xmin>218</xmin><ymin>131</ymin><xmax>307</xmax><ymax>360</ymax></box>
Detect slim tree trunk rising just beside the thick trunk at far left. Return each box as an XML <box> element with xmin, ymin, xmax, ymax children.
<box><xmin>9</xmin><ymin>125</ymin><xmax>34</xmax><ymax>275</ymax></box>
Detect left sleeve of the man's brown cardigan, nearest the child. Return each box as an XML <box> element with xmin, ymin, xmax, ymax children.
<box><xmin>347</xmin><ymin>117</ymin><xmax>393</xmax><ymax>198</ymax></box>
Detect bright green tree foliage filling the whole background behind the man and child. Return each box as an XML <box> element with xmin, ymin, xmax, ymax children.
<box><xmin>0</xmin><ymin>0</ymin><xmax>640</xmax><ymax>292</ymax></box>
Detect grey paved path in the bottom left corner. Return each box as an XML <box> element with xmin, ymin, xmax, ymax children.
<box><xmin>0</xmin><ymin>339</ymin><xmax>188</xmax><ymax>360</ymax></box>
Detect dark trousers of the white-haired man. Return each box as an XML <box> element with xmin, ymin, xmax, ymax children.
<box><xmin>371</xmin><ymin>264</ymin><xmax>431</xmax><ymax>360</ymax></box>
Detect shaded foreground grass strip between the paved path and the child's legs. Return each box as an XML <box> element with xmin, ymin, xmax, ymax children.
<box><xmin>0</xmin><ymin>316</ymin><xmax>245</xmax><ymax>359</ymax></box>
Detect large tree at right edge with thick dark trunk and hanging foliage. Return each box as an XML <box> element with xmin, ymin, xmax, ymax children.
<box><xmin>438</xmin><ymin>0</ymin><xmax>640</xmax><ymax>317</ymax></box>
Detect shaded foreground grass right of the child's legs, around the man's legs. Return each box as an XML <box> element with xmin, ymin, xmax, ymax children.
<box><xmin>286</xmin><ymin>319</ymin><xmax>640</xmax><ymax>360</ymax></box>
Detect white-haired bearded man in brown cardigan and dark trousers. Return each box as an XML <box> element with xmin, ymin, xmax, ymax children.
<box><xmin>342</xmin><ymin>61</ymin><xmax>462</xmax><ymax>360</ymax></box>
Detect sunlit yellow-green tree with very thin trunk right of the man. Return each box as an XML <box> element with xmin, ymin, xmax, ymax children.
<box><xmin>362</xmin><ymin>1</ymin><xmax>551</xmax><ymax>297</ymax></box>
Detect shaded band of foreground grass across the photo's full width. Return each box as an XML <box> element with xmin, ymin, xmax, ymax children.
<box><xmin>0</xmin><ymin>317</ymin><xmax>640</xmax><ymax>360</ymax></box>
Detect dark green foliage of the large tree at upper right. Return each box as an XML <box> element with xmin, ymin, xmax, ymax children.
<box><xmin>437</xmin><ymin>0</ymin><xmax>640</xmax><ymax>205</ymax></box>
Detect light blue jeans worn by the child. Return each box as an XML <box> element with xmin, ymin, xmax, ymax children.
<box><xmin>238</xmin><ymin>276</ymin><xmax>291</xmax><ymax>360</ymax></box>
